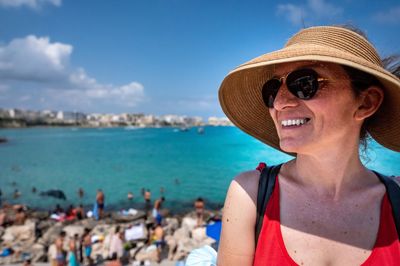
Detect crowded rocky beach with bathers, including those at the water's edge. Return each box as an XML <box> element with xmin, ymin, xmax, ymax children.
<box><xmin>0</xmin><ymin>188</ymin><xmax>221</xmax><ymax>266</ymax></box>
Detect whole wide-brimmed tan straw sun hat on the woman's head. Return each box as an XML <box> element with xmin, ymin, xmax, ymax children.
<box><xmin>219</xmin><ymin>26</ymin><xmax>400</xmax><ymax>154</ymax></box>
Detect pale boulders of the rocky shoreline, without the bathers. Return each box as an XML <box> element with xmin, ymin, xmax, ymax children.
<box><xmin>0</xmin><ymin>206</ymin><xmax>221</xmax><ymax>265</ymax></box>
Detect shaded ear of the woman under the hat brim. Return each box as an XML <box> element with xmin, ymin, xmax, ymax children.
<box><xmin>354</xmin><ymin>86</ymin><xmax>383</xmax><ymax>120</ymax></box>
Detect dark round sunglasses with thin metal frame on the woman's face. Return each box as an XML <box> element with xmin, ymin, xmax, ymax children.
<box><xmin>262</xmin><ymin>68</ymin><xmax>327</xmax><ymax>108</ymax></box>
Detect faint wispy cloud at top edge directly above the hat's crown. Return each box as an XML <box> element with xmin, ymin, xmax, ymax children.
<box><xmin>277</xmin><ymin>0</ymin><xmax>343</xmax><ymax>25</ymax></box>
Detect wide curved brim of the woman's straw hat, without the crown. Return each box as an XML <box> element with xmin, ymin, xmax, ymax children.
<box><xmin>219</xmin><ymin>44</ymin><xmax>400</xmax><ymax>155</ymax></box>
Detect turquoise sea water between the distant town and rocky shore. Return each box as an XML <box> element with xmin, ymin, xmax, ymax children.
<box><xmin>0</xmin><ymin>127</ymin><xmax>400</xmax><ymax>214</ymax></box>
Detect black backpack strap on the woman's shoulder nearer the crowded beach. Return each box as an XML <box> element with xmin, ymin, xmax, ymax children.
<box><xmin>255</xmin><ymin>164</ymin><xmax>282</xmax><ymax>246</ymax></box>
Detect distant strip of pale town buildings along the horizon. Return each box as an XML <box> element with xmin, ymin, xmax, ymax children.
<box><xmin>0</xmin><ymin>108</ymin><xmax>232</xmax><ymax>128</ymax></box>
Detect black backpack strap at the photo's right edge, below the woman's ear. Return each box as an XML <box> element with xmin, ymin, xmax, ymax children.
<box><xmin>373</xmin><ymin>171</ymin><xmax>400</xmax><ymax>240</ymax></box>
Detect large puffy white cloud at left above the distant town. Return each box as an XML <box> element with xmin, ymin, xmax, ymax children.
<box><xmin>0</xmin><ymin>35</ymin><xmax>145</xmax><ymax>111</ymax></box>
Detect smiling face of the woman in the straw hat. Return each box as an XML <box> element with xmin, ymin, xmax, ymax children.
<box><xmin>269</xmin><ymin>61</ymin><xmax>362</xmax><ymax>154</ymax></box>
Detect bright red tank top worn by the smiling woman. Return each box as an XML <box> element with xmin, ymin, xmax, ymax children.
<box><xmin>254</xmin><ymin>177</ymin><xmax>400</xmax><ymax>266</ymax></box>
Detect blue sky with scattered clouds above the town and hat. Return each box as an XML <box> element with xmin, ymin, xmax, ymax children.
<box><xmin>0</xmin><ymin>0</ymin><xmax>400</xmax><ymax>118</ymax></box>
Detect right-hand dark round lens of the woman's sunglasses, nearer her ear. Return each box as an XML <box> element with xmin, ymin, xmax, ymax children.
<box><xmin>286</xmin><ymin>69</ymin><xmax>318</xmax><ymax>100</ymax></box>
